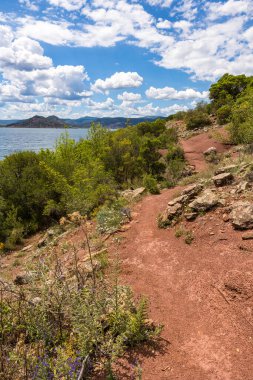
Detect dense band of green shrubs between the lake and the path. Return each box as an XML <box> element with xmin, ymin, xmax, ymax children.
<box><xmin>0</xmin><ymin>120</ymin><xmax>185</xmax><ymax>248</ymax></box>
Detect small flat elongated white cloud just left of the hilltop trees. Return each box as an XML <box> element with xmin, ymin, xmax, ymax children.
<box><xmin>146</xmin><ymin>87</ymin><xmax>209</xmax><ymax>100</ymax></box>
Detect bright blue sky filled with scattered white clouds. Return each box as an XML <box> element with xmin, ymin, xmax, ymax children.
<box><xmin>0</xmin><ymin>0</ymin><xmax>253</xmax><ymax>119</ymax></box>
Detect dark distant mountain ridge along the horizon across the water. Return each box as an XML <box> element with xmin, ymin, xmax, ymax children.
<box><xmin>0</xmin><ymin>115</ymin><xmax>164</xmax><ymax>129</ymax></box>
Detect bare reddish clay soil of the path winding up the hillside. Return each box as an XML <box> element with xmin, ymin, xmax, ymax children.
<box><xmin>111</xmin><ymin>134</ymin><xmax>253</xmax><ymax>380</ymax></box>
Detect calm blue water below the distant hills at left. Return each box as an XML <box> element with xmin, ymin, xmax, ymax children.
<box><xmin>0</xmin><ymin>128</ymin><xmax>88</xmax><ymax>160</ymax></box>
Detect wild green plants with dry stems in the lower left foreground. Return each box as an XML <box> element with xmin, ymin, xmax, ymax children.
<box><xmin>0</xmin><ymin>249</ymin><xmax>160</xmax><ymax>380</ymax></box>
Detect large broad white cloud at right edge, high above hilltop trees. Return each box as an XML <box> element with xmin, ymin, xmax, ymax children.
<box><xmin>156</xmin><ymin>16</ymin><xmax>253</xmax><ymax>80</ymax></box>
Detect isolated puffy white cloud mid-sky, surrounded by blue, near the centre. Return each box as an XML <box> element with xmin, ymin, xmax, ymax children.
<box><xmin>91</xmin><ymin>72</ymin><xmax>143</xmax><ymax>92</ymax></box>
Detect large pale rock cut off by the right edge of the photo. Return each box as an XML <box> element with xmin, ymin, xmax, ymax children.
<box><xmin>230</xmin><ymin>201</ymin><xmax>253</xmax><ymax>230</ymax></box>
